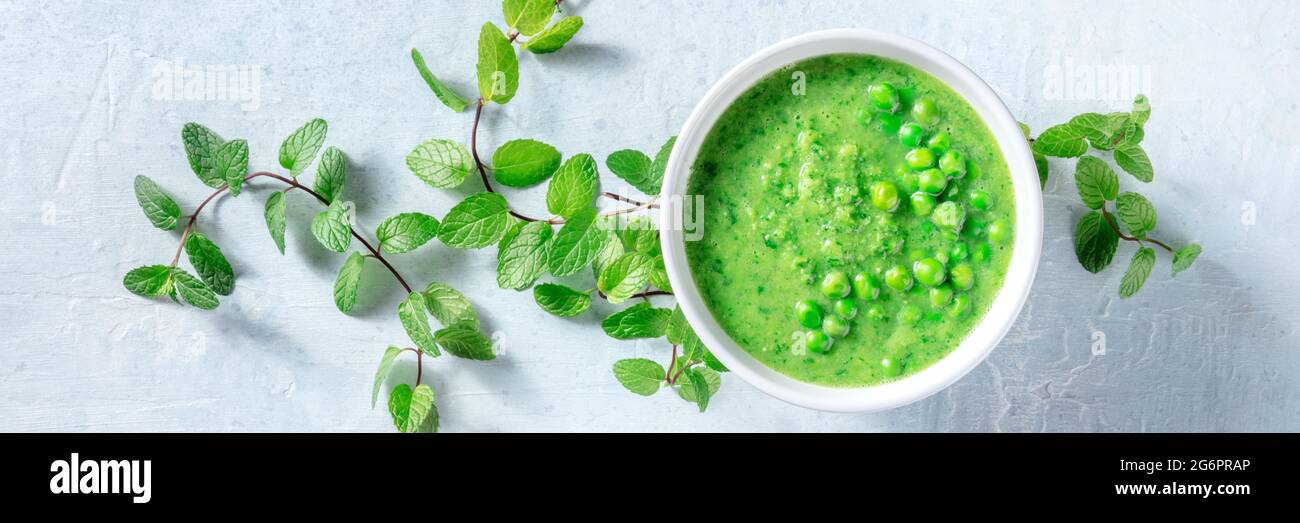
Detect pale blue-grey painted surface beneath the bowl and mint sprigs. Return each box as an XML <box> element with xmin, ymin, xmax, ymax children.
<box><xmin>0</xmin><ymin>0</ymin><xmax>1300</xmax><ymax>431</ymax></box>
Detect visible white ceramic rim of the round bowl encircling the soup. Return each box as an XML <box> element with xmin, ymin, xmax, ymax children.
<box><xmin>659</xmin><ymin>29</ymin><xmax>1043</xmax><ymax>412</ymax></box>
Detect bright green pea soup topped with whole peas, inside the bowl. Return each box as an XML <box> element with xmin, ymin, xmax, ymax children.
<box><xmin>686</xmin><ymin>55</ymin><xmax>1015</xmax><ymax>386</ymax></box>
